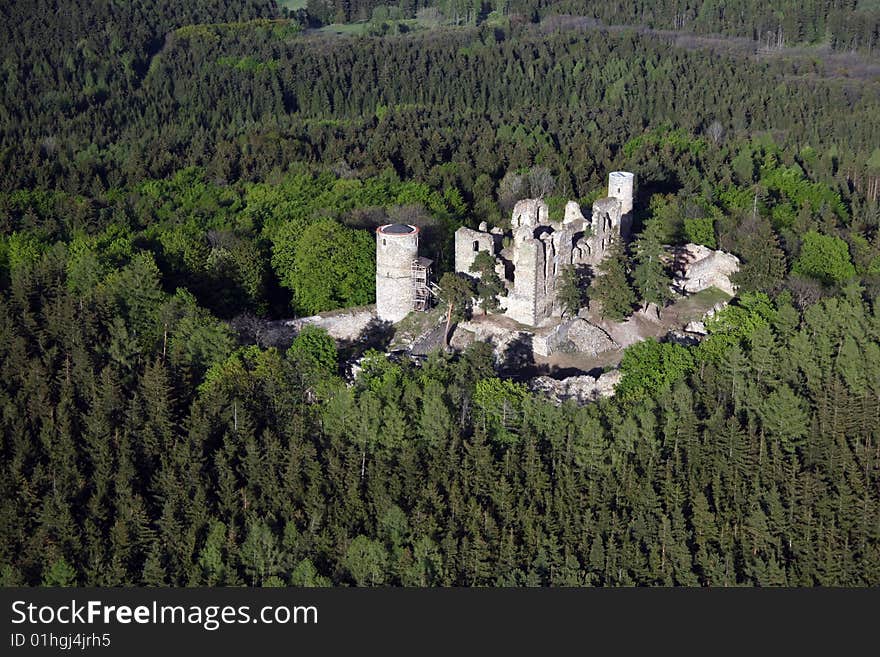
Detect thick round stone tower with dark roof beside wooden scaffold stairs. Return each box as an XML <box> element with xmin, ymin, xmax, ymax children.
<box><xmin>376</xmin><ymin>224</ymin><xmax>419</xmax><ymax>322</ymax></box>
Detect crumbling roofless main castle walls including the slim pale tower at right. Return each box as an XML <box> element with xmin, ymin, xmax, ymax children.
<box><xmin>455</xmin><ymin>171</ymin><xmax>635</xmax><ymax>326</ymax></box>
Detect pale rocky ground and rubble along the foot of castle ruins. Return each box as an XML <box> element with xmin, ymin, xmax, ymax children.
<box><xmin>233</xmin><ymin>245</ymin><xmax>738</xmax><ymax>403</ymax></box>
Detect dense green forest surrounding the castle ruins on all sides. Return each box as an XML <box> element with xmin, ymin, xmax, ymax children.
<box><xmin>0</xmin><ymin>0</ymin><xmax>880</xmax><ymax>586</ymax></box>
